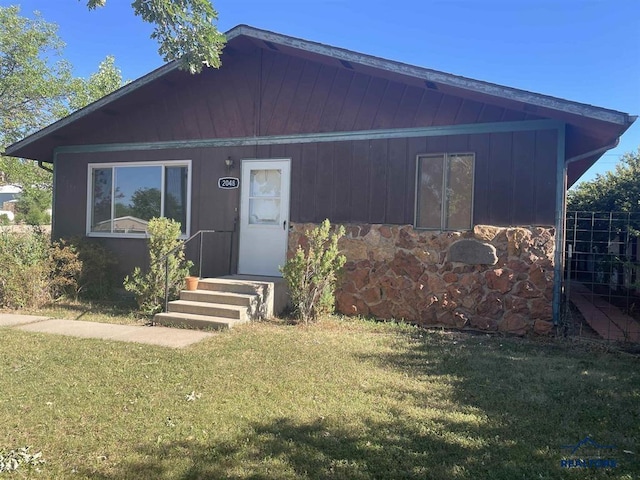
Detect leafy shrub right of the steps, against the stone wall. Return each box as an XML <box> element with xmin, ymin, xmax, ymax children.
<box><xmin>280</xmin><ymin>220</ymin><xmax>346</xmax><ymax>323</ymax></box>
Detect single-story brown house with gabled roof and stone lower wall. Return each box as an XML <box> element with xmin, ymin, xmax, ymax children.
<box><xmin>7</xmin><ymin>25</ymin><xmax>635</xmax><ymax>334</ymax></box>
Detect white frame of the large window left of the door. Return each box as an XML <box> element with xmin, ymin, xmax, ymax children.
<box><xmin>85</xmin><ymin>160</ymin><xmax>193</xmax><ymax>239</ymax></box>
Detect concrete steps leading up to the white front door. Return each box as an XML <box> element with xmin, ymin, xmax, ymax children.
<box><xmin>154</xmin><ymin>276</ymin><xmax>286</xmax><ymax>329</ymax></box>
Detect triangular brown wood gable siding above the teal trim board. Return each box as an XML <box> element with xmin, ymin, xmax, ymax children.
<box><xmin>53</xmin><ymin>49</ymin><xmax>556</xmax><ymax>149</ymax></box>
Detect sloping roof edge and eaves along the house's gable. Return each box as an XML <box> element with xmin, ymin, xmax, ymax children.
<box><xmin>5</xmin><ymin>25</ymin><xmax>636</xmax><ymax>183</ymax></box>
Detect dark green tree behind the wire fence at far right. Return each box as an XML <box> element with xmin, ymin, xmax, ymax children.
<box><xmin>567</xmin><ymin>148</ymin><xmax>640</xmax><ymax>212</ymax></box>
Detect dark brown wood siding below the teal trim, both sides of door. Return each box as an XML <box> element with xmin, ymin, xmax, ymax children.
<box><xmin>53</xmin><ymin>130</ymin><xmax>556</xmax><ymax>275</ymax></box>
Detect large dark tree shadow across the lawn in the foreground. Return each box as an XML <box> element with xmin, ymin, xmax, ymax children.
<box><xmin>77</xmin><ymin>337</ymin><xmax>640</xmax><ymax>480</ymax></box>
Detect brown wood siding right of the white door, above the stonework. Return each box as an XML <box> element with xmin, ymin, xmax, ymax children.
<box><xmin>291</xmin><ymin>131</ymin><xmax>556</xmax><ymax>226</ymax></box>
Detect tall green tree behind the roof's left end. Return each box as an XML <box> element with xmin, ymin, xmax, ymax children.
<box><xmin>0</xmin><ymin>6</ymin><xmax>122</xmax><ymax>223</ymax></box>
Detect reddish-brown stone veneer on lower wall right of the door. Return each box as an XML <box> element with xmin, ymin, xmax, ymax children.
<box><xmin>289</xmin><ymin>224</ymin><xmax>554</xmax><ymax>335</ymax></box>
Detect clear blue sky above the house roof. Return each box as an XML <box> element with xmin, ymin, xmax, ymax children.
<box><xmin>10</xmin><ymin>0</ymin><xmax>640</xmax><ymax>185</ymax></box>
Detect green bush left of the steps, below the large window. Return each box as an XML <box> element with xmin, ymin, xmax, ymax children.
<box><xmin>124</xmin><ymin>218</ymin><xmax>193</xmax><ymax>315</ymax></box>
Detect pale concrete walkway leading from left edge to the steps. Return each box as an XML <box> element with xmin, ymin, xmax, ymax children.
<box><xmin>0</xmin><ymin>314</ymin><xmax>214</xmax><ymax>348</ymax></box>
